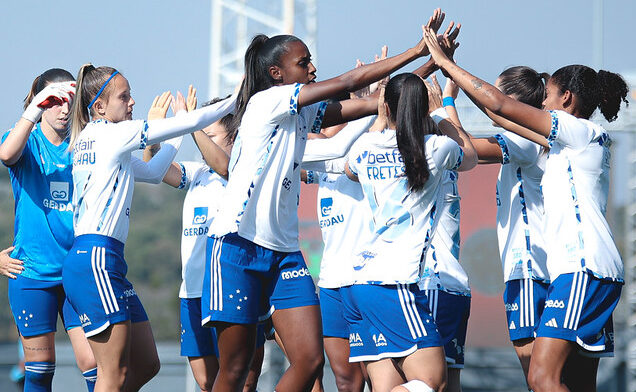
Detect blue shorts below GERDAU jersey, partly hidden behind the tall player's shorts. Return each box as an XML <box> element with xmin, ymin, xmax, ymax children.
<box><xmin>181</xmin><ymin>298</ymin><xmax>219</xmax><ymax>358</ymax></box>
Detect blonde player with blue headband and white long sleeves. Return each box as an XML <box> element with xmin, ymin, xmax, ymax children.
<box><xmin>63</xmin><ymin>64</ymin><xmax>233</xmax><ymax>390</ymax></box>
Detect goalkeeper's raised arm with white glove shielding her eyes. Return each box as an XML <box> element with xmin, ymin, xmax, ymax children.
<box><xmin>0</xmin><ymin>82</ymin><xmax>75</xmax><ymax>166</ymax></box>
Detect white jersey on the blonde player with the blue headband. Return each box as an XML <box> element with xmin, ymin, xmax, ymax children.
<box><xmin>73</xmin><ymin>120</ymin><xmax>181</xmax><ymax>243</ymax></box>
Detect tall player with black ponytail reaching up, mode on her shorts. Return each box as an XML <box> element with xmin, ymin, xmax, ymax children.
<box><xmin>202</xmin><ymin>8</ymin><xmax>448</xmax><ymax>391</ymax></box>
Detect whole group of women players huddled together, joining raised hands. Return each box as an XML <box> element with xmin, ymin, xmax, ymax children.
<box><xmin>0</xmin><ymin>9</ymin><xmax>628</xmax><ymax>392</ymax></box>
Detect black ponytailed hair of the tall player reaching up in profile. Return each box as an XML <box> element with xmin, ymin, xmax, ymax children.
<box><xmin>232</xmin><ymin>34</ymin><xmax>302</xmax><ymax>129</ymax></box>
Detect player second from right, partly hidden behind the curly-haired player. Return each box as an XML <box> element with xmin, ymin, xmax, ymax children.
<box><xmin>454</xmin><ymin>66</ymin><xmax>550</xmax><ymax>380</ymax></box>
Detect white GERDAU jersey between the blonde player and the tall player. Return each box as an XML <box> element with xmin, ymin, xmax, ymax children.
<box><xmin>179</xmin><ymin>162</ymin><xmax>226</xmax><ymax>298</ymax></box>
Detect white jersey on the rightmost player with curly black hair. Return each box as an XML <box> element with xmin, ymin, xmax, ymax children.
<box><xmin>541</xmin><ymin>111</ymin><xmax>623</xmax><ymax>282</ymax></box>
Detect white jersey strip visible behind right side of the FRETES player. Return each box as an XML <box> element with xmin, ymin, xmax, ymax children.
<box><xmin>418</xmin><ymin>170</ymin><xmax>470</xmax><ymax>296</ymax></box>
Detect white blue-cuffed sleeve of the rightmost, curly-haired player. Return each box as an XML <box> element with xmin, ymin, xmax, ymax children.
<box><xmin>547</xmin><ymin>110</ymin><xmax>595</xmax><ymax>150</ymax></box>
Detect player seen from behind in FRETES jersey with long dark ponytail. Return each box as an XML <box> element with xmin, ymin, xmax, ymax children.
<box><xmin>341</xmin><ymin>74</ymin><xmax>477</xmax><ymax>391</ymax></box>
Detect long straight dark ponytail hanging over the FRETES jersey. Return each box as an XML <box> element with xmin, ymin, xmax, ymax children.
<box><xmin>385</xmin><ymin>73</ymin><xmax>434</xmax><ymax>192</ymax></box>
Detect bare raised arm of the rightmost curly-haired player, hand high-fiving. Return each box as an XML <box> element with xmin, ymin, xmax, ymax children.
<box><xmin>424</xmin><ymin>28</ymin><xmax>552</xmax><ymax>137</ymax></box>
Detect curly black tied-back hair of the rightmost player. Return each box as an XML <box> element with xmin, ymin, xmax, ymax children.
<box><xmin>550</xmin><ymin>65</ymin><xmax>629</xmax><ymax>122</ymax></box>
